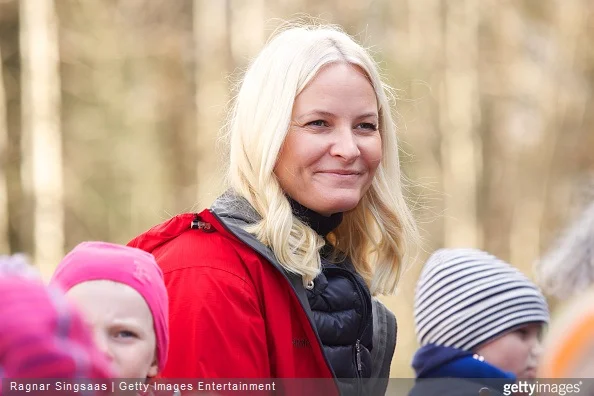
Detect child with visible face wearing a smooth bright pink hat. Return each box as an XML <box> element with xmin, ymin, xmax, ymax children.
<box><xmin>50</xmin><ymin>242</ymin><xmax>169</xmax><ymax>378</ymax></box>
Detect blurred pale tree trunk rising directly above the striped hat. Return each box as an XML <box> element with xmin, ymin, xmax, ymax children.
<box><xmin>440</xmin><ymin>0</ymin><xmax>482</xmax><ymax>247</ymax></box>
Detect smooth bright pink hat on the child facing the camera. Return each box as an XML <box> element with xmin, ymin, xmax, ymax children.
<box><xmin>50</xmin><ymin>242</ymin><xmax>169</xmax><ymax>371</ymax></box>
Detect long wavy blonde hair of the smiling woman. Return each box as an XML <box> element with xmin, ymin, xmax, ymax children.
<box><xmin>226</xmin><ymin>21</ymin><xmax>418</xmax><ymax>294</ymax></box>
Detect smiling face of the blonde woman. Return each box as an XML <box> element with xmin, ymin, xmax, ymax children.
<box><xmin>274</xmin><ymin>63</ymin><xmax>382</xmax><ymax>216</ymax></box>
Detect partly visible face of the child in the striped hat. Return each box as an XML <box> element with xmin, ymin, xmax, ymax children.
<box><xmin>475</xmin><ymin>323</ymin><xmax>542</xmax><ymax>379</ymax></box>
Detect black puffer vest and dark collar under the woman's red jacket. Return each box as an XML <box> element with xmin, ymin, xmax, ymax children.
<box><xmin>291</xmin><ymin>200</ymin><xmax>373</xmax><ymax>395</ymax></box>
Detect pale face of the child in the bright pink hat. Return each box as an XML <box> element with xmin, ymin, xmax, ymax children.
<box><xmin>67</xmin><ymin>280</ymin><xmax>157</xmax><ymax>378</ymax></box>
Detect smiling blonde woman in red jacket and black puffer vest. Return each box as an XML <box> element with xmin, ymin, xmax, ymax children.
<box><xmin>130</xmin><ymin>22</ymin><xmax>416</xmax><ymax>394</ymax></box>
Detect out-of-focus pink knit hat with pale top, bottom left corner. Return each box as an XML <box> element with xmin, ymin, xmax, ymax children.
<box><xmin>0</xmin><ymin>256</ymin><xmax>112</xmax><ymax>386</ymax></box>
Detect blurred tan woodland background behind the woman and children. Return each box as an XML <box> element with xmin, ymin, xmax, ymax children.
<box><xmin>0</xmin><ymin>0</ymin><xmax>594</xmax><ymax>377</ymax></box>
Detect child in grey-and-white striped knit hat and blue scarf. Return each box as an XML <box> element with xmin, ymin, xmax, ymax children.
<box><xmin>411</xmin><ymin>249</ymin><xmax>549</xmax><ymax>395</ymax></box>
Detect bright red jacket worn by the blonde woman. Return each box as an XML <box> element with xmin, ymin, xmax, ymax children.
<box><xmin>129</xmin><ymin>204</ymin><xmax>334</xmax><ymax>394</ymax></box>
